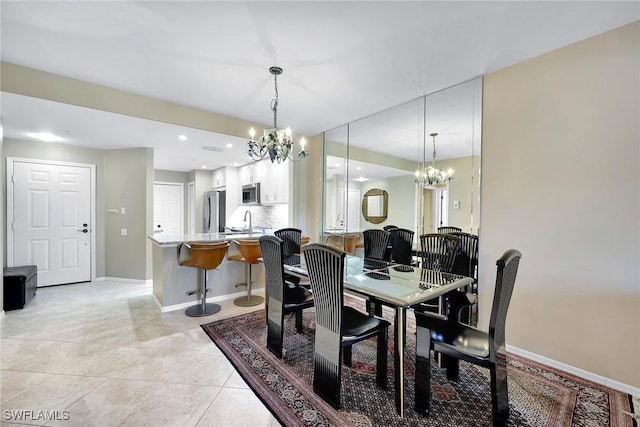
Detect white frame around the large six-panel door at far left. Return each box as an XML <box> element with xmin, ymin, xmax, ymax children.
<box><xmin>5</xmin><ymin>157</ymin><xmax>97</xmax><ymax>282</ymax></box>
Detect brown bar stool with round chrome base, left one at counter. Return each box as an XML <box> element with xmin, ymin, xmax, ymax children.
<box><xmin>178</xmin><ymin>242</ymin><xmax>229</xmax><ymax>317</ymax></box>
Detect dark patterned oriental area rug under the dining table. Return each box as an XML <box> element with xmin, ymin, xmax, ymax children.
<box><xmin>202</xmin><ymin>300</ymin><xmax>637</xmax><ymax>427</ymax></box>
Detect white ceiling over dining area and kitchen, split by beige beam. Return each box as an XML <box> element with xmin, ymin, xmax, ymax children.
<box><xmin>0</xmin><ymin>0</ymin><xmax>640</xmax><ymax>170</ymax></box>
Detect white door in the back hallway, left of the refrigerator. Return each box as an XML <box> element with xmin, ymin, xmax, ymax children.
<box><xmin>153</xmin><ymin>182</ymin><xmax>184</xmax><ymax>235</ymax></box>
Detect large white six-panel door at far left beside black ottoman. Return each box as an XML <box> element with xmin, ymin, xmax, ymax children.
<box><xmin>8</xmin><ymin>161</ymin><xmax>93</xmax><ymax>286</ymax></box>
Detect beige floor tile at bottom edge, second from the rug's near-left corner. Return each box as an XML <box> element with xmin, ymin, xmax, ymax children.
<box><xmin>121</xmin><ymin>384</ymin><xmax>220</xmax><ymax>427</ymax></box>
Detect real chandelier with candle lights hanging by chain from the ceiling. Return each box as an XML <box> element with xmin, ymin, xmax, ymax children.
<box><xmin>247</xmin><ymin>67</ymin><xmax>308</xmax><ymax>163</ymax></box>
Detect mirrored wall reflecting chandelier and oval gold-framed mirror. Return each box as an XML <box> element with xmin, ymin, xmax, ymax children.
<box><xmin>323</xmin><ymin>78</ymin><xmax>482</xmax><ymax>246</ymax></box>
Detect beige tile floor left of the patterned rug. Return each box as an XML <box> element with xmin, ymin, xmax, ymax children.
<box><xmin>0</xmin><ymin>281</ymin><xmax>280</xmax><ymax>427</ymax></box>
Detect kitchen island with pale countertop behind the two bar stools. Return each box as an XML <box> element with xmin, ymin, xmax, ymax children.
<box><xmin>149</xmin><ymin>233</ymin><xmax>264</xmax><ymax>312</ymax></box>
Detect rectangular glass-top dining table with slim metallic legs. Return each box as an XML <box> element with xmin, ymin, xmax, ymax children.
<box><xmin>284</xmin><ymin>252</ymin><xmax>473</xmax><ymax>418</ymax></box>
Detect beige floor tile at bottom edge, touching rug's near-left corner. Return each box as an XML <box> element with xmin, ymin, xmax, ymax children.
<box><xmin>197</xmin><ymin>388</ymin><xmax>274</xmax><ymax>427</ymax></box>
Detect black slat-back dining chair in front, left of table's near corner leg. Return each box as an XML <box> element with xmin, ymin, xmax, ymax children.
<box><xmin>304</xmin><ymin>243</ymin><xmax>390</xmax><ymax>408</ymax></box>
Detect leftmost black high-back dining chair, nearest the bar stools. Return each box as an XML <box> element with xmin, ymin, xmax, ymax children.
<box><xmin>259</xmin><ymin>236</ymin><xmax>313</xmax><ymax>358</ymax></box>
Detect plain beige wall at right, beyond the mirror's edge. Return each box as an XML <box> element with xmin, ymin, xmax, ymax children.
<box><xmin>480</xmin><ymin>22</ymin><xmax>640</xmax><ymax>387</ymax></box>
